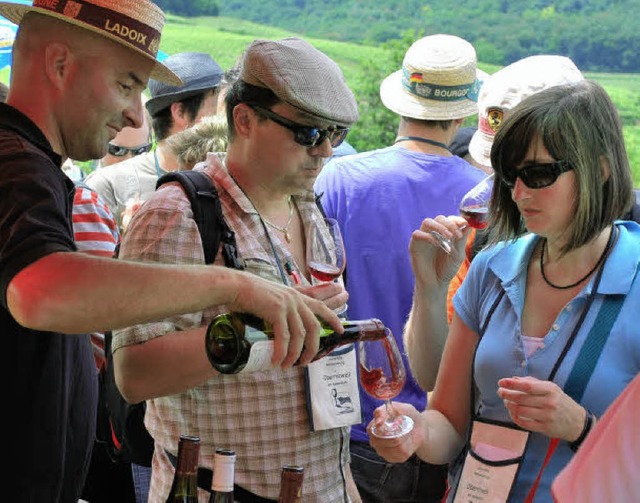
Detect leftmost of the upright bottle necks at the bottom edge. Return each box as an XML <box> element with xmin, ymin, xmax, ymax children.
<box><xmin>167</xmin><ymin>435</ymin><xmax>200</xmax><ymax>503</ymax></box>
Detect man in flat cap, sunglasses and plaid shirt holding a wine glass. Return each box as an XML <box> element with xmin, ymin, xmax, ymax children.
<box><xmin>113</xmin><ymin>38</ymin><xmax>360</xmax><ymax>503</ymax></box>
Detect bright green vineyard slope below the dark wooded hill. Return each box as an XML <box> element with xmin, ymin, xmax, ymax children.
<box><xmin>0</xmin><ymin>15</ymin><xmax>640</xmax><ymax>181</ymax></box>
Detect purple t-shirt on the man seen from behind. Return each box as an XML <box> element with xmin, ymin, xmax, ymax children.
<box><xmin>315</xmin><ymin>146</ymin><xmax>486</xmax><ymax>442</ymax></box>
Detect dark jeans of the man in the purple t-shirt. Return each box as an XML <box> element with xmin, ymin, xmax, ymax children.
<box><xmin>351</xmin><ymin>440</ymin><xmax>447</xmax><ymax>503</ymax></box>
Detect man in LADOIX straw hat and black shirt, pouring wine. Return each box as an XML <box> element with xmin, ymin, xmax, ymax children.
<box><xmin>0</xmin><ymin>0</ymin><xmax>341</xmax><ymax>503</ymax></box>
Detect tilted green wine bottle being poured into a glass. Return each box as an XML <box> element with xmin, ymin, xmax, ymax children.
<box><xmin>205</xmin><ymin>313</ymin><xmax>389</xmax><ymax>374</ymax></box>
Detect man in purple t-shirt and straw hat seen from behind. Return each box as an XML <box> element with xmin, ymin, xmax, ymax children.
<box><xmin>315</xmin><ymin>35</ymin><xmax>485</xmax><ymax>502</ymax></box>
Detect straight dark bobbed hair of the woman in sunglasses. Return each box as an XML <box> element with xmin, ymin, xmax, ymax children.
<box><xmin>490</xmin><ymin>81</ymin><xmax>633</xmax><ymax>253</ymax></box>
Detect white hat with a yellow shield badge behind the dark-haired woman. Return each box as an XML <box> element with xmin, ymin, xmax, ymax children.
<box><xmin>469</xmin><ymin>54</ymin><xmax>584</xmax><ymax>167</ymax></box>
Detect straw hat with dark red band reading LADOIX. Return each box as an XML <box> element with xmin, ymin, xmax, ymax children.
<box><xmin>0</xmin><ymin>0</ymin><xmax>182</xmax><ymax>86</ymax></box>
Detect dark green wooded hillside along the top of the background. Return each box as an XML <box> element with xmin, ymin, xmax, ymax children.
<box><xmin>220</xmin><ymin>0</ymin><xmax>640</xmax><ymax>72</ymax></box>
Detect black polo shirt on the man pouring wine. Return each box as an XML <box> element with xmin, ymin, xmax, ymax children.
<box><xmin>0</xmin><ymin>103</ymin><xmax>98</xmax><ymax>503</ymax></box>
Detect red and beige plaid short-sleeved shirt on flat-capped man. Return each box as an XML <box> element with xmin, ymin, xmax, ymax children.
<box><xmin>114</xmin><ymin>154</ymin><xmax>349</xmax><ymax>503</ymax></box>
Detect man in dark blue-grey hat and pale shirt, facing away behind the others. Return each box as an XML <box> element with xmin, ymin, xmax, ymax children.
<box><xmin>85</xmin><ymin>52</ymin><xmax>224</xmax><ymax>231</ymax></box>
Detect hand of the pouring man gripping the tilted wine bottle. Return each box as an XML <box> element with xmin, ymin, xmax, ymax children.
<box><xmin>228</xmin><ymin>273</ymin><xmax>344</xmax><ymax>368</ymax></box>
